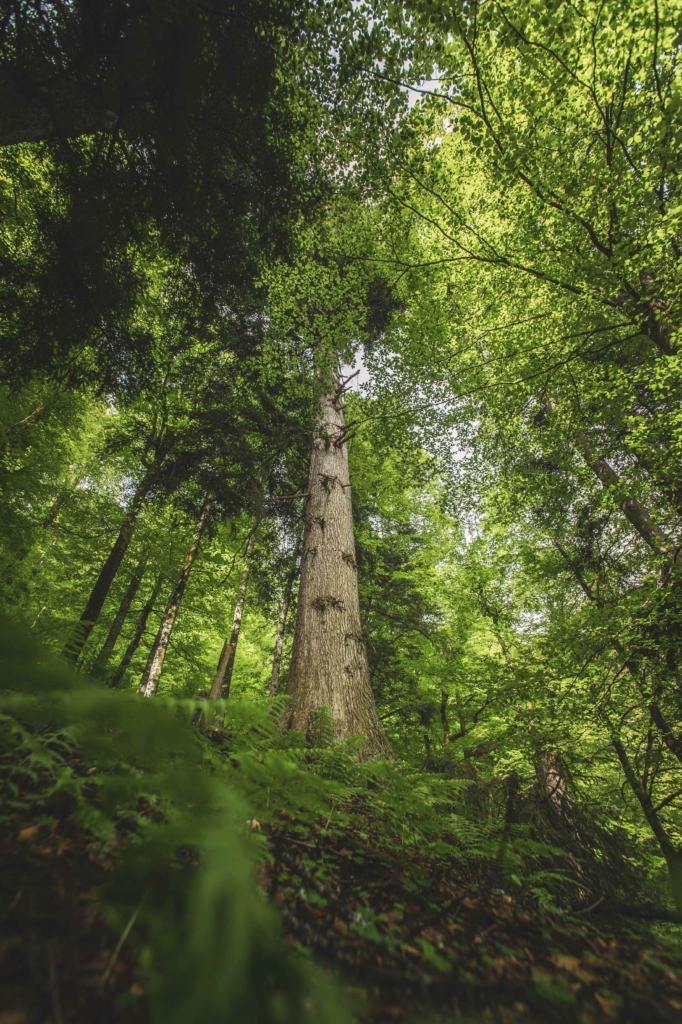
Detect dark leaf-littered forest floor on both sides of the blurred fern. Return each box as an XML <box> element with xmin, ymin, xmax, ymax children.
<box><xmin>0</xmin><ymin>798</ymin><xmax>682</xmax><ymax>1024</ymax></box>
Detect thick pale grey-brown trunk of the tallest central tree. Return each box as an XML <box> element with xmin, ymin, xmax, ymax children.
<box><xmin>282</xmin><ymin>389</ymin><xmax>392</xmax><ymax>758</ymax></box>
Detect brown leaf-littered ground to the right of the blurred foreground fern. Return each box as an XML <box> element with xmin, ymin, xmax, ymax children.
<box><xmin>259</xmin><ymin>822</ymin><xmax>682</xmax><ymax>1024</ymax></box>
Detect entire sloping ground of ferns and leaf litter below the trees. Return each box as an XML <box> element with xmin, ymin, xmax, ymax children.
<box><xmin>0</xmin><ymin>626</ymin><xmax>682</xmax><ymax>1024</ymax></box>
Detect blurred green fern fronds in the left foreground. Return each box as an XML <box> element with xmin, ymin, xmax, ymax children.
<box><xmin>2</xmin><ymin>628</ymin><xmax>350</xmax><ymax>1021</ymax></box>
